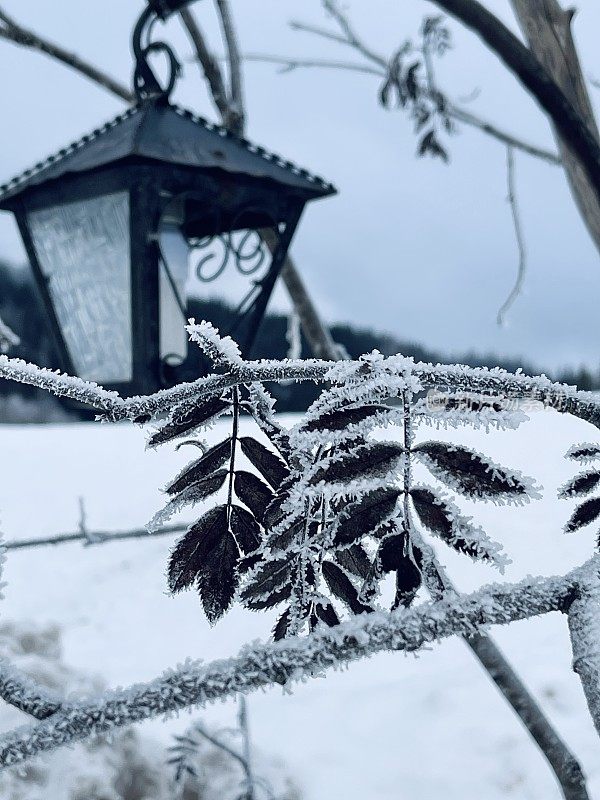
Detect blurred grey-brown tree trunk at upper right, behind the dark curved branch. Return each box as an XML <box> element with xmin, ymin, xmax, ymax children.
<box><xmin>511</xmin><ymin>0</ymin><xmax>600</xmax><ymax>251</ymax></box>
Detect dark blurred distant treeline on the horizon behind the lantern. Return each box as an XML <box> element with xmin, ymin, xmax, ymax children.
<box><xmin>0</xmin><ymin>261</ymin><xmax>600</xmax><ymax>422</ymax></box>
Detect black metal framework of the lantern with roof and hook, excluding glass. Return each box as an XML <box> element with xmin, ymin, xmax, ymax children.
<box><xmin>0</xmin><ymin>0</ymin><xmax>335</xmax><ymax>395</ymax></box>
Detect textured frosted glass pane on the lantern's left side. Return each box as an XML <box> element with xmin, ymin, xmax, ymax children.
<box><xmin>28</xmin><ymin>192</ymin><xmax>133</xmax><ymax>383</ymax></box>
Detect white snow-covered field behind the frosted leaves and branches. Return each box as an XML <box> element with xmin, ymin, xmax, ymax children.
<box><xmin>0</xmin><ymin>410</ymin><xmax>600</xmax><ymax>800</ymax></box>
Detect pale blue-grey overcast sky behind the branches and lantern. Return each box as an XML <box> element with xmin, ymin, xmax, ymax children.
<box><xmin>0</xmin><ymin>0</ymin><xmax>600</xmax><ymax>368</ymax></box>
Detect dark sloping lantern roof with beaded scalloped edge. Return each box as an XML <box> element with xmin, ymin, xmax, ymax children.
<box><xmin>0</xmin><ymin>102</ymin><xmax>336</xmax><ymax>208</ymax></box>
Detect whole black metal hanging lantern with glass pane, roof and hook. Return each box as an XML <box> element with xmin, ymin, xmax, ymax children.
<box><xmin>0</xmin><ymin>0</ymin><xmax>335</xmax><ymax>394</ymax></box>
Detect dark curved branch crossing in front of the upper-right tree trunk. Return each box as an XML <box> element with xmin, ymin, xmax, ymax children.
<box><xmin>432</xmin><ymin>0</ymin><xmax>600</xmax><ymax>208</ymax></box>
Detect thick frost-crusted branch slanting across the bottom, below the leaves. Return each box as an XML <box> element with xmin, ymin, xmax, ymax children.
<box><xmin>0</xmin><ymin>568</ymin><xmax>585</xmax><ymax>767</ymax></box>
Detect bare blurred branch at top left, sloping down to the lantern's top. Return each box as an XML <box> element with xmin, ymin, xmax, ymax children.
<box><xmin>0</xmin><ymin>8</ymin><xmax>135</xmax><ymax>103</ymax></box>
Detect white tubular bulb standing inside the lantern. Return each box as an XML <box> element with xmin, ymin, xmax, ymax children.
<box><xmin>158</xmin><ymin>225</ymin><xmax>189</xmax><ymax>366</ymax></box>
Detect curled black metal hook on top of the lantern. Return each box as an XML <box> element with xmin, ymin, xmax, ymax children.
<box><xmin>132</xmin><ymin>2</ymin><xmax>184</xmax><ymax>102</ymax></box>
